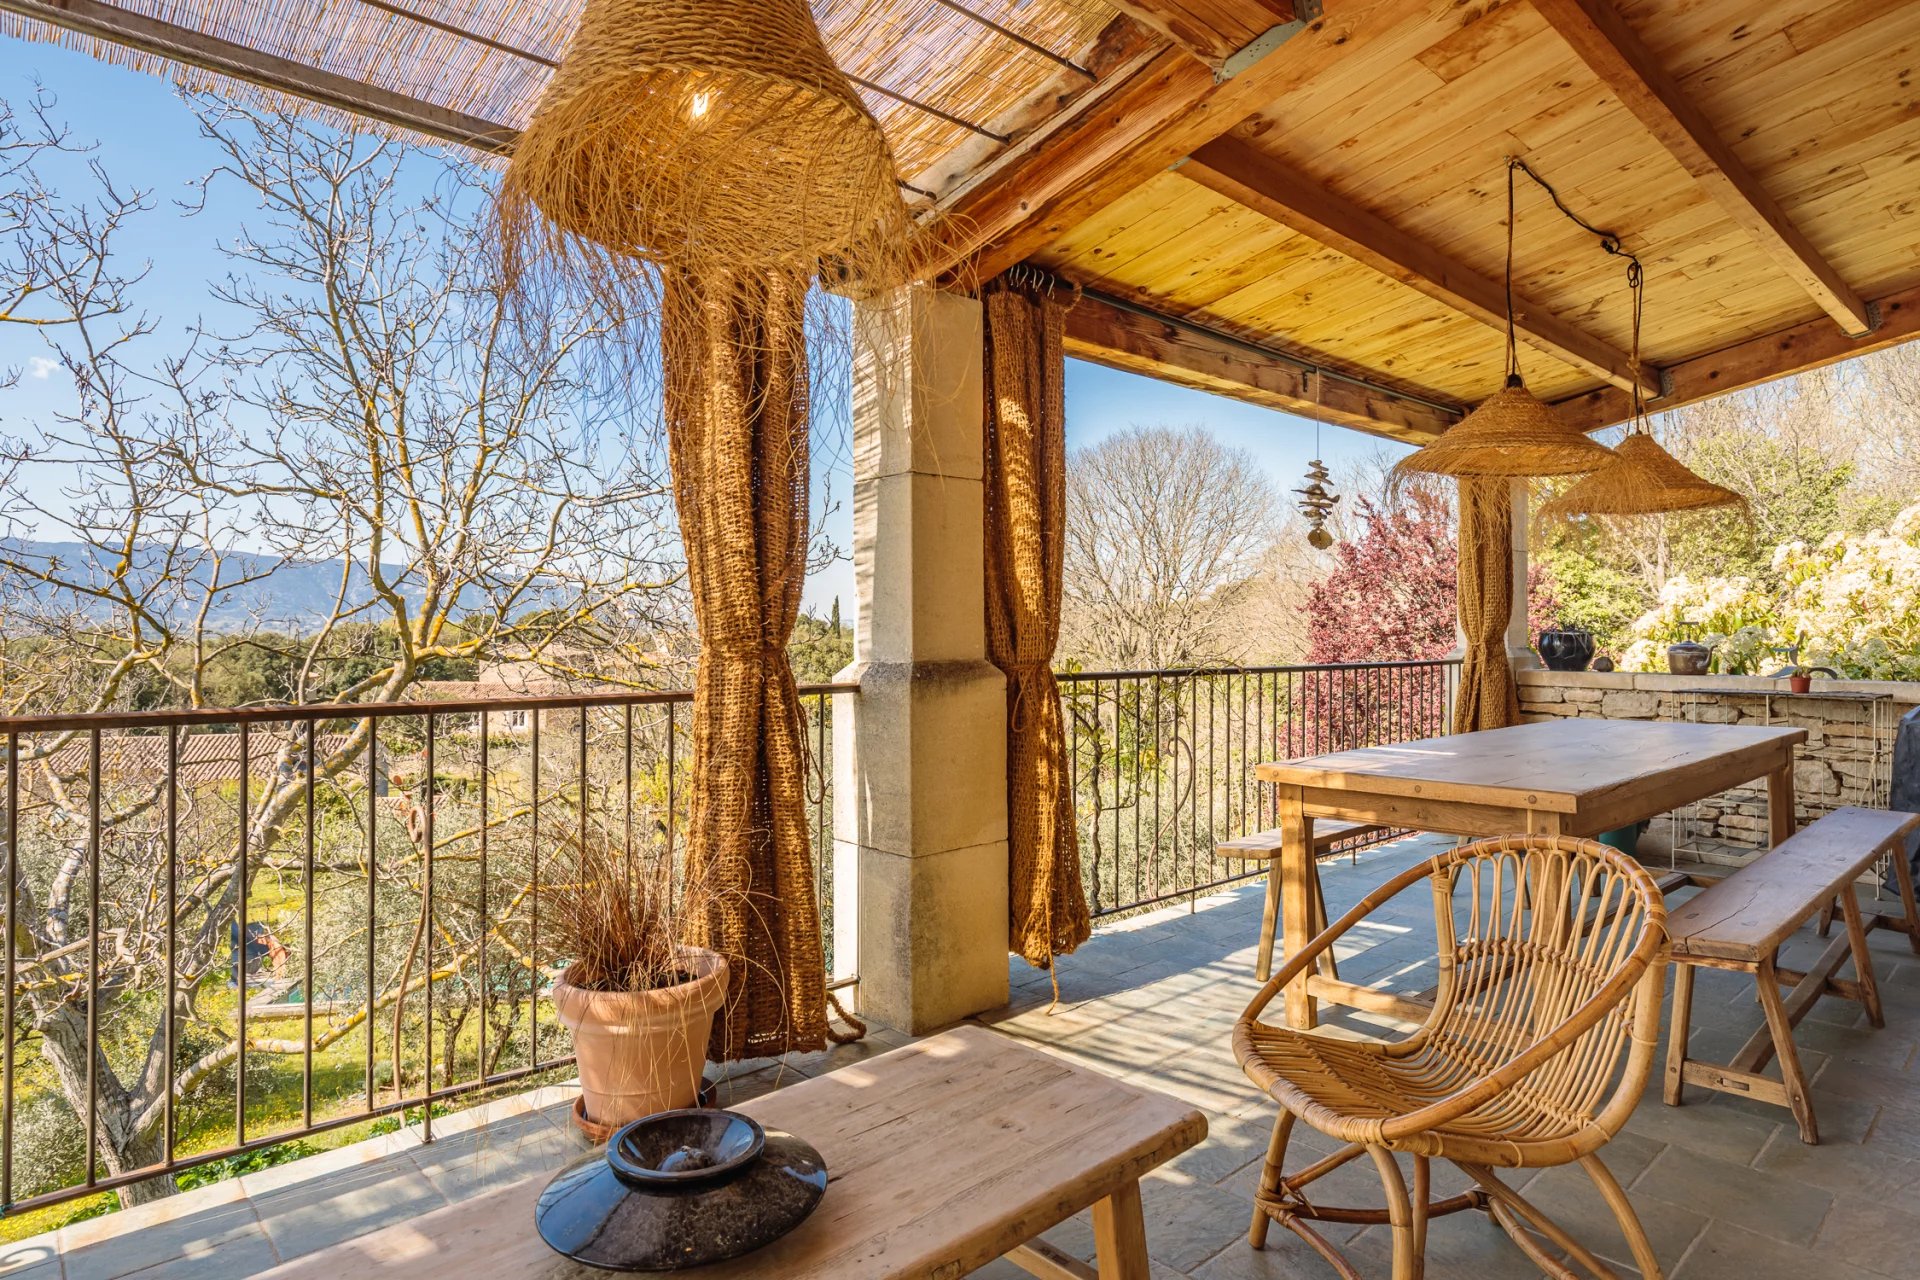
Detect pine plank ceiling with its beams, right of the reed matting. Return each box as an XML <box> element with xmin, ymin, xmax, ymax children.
<box><xmin>967</xmin><ymin>0</ymin><xmax>1920</xmax><ymax>439</ymax></box>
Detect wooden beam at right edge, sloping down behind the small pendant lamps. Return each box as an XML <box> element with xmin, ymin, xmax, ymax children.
<box><xmin>1555</xmin><ymin>288</ymin><xmax>1920</xmax><ymax>432</ymax></box>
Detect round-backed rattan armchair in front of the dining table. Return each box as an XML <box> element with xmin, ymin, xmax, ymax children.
<box><xmin>1233</xmin><ymin>837</ymin><xmax>1667</xmax><ymax>1280</ymax></box>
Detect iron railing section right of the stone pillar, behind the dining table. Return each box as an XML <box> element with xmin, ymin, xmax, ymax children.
<box><xmin>1060</xmin><ymin>658</ymin><xmax>1459</xmax><ymax>915</ymax></box>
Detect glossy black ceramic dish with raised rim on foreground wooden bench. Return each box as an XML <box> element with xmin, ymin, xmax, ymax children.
<box><xmin>534</xmin><ymin>1109</ymin><xmax>828</xmax><ymax>1270</ymax></box>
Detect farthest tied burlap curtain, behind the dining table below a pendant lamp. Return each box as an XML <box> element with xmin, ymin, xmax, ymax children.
<box><xmin>1453</xmin><ymin>476</ymin><xmax>1521</xmax><ymax>733</ymax></box>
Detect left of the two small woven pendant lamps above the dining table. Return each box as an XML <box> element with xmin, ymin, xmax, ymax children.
<box><xmin>1398</xmin><ymin>161</ymin><xmax>1613</xmax><ymax>480</ymax></box>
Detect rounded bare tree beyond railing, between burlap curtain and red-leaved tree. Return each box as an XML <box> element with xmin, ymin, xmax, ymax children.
<box><xmin>1062</xmin><ymin>426</ymin><xmax>1275</xmax><ymax>668</ymax></box>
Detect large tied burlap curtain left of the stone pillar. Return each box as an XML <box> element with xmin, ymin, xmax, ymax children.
<box><xmin>660</xmin><ymin>273</ymin><xmax>826</xmax><ymax>1061</ymax></box>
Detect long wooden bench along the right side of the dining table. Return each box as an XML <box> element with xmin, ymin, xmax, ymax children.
<box><xmin>1665</xmin><ymin>808</ymin><xmax>1920</xmax><ymax>1144</ymax></box>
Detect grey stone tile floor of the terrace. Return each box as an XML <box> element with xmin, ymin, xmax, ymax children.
<box><xmin>11</xmin><ymin>839</ymin><xmax>1920</xmax><ymax>1280</ymax></box>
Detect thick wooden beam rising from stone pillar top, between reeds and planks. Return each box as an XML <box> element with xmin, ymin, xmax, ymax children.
<box><xmin>935</xmin><ymin>0</ymin><xmax>1359</xmax><ymax>284</ymax></box>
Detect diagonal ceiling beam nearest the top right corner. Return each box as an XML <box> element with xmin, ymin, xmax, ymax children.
<box><xmin>1534</xmin><ymin>0</ymin><xmax>1872</xmax><ymax>338</ymax></box>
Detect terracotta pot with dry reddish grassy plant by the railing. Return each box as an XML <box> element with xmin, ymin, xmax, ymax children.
<box><xmin>540</xmin><ymin>839</ymin><xmax>728</xmax><ymax>1140</ymax></box>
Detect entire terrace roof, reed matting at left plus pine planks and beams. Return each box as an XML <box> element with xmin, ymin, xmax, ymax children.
<box><xmin>15</xmin><ymin>0</ymin><xmax>1920</xmax><ymax>449</ymax></box>
